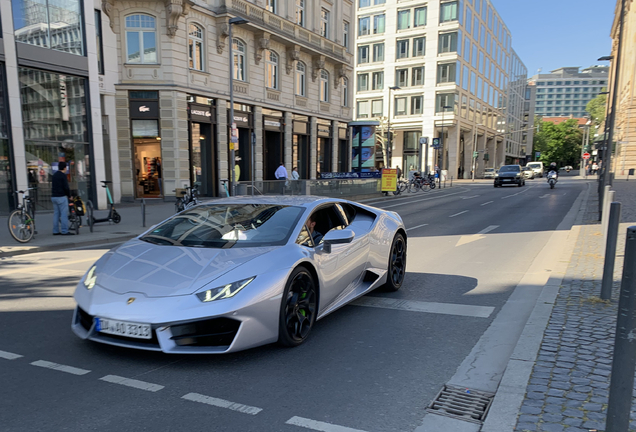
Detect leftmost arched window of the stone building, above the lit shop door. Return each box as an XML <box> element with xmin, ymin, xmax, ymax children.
<box><xmin>126</xmin><ymin>14</ymin><xmax>157</xmax><ymax>64</ymax></box>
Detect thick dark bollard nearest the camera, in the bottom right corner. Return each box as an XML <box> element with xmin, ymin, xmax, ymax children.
<box><xmin>605</xmin><ymin>226</ymin><xmax>636</xmax><ymax>432</ymax></box>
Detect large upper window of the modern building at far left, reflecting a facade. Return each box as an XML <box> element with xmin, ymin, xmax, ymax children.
<box><xmin>10</xmin><ymin>0</ymin><xmax>84</xmax><ymax>56</ymax></box>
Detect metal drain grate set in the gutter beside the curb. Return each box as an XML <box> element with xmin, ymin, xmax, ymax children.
<box><xmin>428</xmin><ymin>385</ymin><xmax>495</xmax><ymax>423</ymax></box>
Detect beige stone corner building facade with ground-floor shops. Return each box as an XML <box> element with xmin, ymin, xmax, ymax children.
<box><xmin>102</xmin><ymin>0</ymin><xmax>353</xmax><ymax>200</ymax></box>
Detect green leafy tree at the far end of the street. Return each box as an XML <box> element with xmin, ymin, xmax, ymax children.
<box><xmin>533</xmin><ymin>119</ymin><xmax>583</xmax><ymax>167</ymax></box>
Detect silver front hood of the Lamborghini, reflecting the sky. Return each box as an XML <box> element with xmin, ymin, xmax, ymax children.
<box><xmin>96</xmin><ymin>240</ymin><xmax>281</xmax><ymax>297</ymax></box>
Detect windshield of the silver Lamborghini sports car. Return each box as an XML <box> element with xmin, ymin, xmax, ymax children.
<box><xmin>141</xmin><ymin>204</ymin><xmax>304</xmax><ymax>249</ymax></box>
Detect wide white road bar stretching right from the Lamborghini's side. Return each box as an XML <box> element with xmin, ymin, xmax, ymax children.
<box><xmin>351</xmin><ymin>296</ymin><xmax>495</xmax><ymax>318</ymax></box>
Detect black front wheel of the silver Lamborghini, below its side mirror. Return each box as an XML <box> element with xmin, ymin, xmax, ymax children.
<box><xmin>278</xmin><ymin>267</ymin><xmax>318</xmax><ymax>347</ymax></box>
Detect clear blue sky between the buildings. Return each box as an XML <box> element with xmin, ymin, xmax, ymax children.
<box><xmin>490</xmin><ymin>0</ymin><xmax>616</xmax><ymax>77</ymax></box>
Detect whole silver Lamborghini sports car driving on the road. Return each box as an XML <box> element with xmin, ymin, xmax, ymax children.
<box><xmin>72</xmin><ymin>196</ymin><xmax>406</xmax><ymax>353</ymax></box>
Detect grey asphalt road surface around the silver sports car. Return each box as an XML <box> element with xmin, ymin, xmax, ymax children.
<box><xmin>0</xmin><ymin>178</ymin><xmax>585</xmax><ymax>432</ymax></box>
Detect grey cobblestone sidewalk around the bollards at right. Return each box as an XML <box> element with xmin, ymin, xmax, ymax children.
<box><xmin>515</xmin><ymin>179</ymin><xmax>636</xmax><ymax>432</ymax></box>
